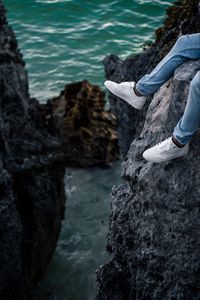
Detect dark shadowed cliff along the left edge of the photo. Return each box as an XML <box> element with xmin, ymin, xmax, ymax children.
<box><xmin>0</xmin><ymin>1</ymin><xmax>64</xmax><ymax>300</ymax></box>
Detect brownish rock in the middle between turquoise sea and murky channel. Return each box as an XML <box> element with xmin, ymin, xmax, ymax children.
<box><xmin>46</xmin><ymin>80</ymin><xmax>119</xmax><ymax>167</ymax></box>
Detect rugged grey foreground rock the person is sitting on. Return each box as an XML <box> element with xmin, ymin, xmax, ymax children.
<box><xmin>96</xmin><ymin>57</ymin><xmax>200</xmax><ymax>300</ymax></box>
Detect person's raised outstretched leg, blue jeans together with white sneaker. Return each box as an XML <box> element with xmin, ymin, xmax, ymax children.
<box><xmin>104</xmin><ymin>33</ymin><xmax>200</xmax><ymax>109</ymax></box>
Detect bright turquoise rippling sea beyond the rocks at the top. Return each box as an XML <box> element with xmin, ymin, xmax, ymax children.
<box><xmin>4</xmin><ymin>0</ymin><xmax>173</xmax><ymax>102</ymax></box>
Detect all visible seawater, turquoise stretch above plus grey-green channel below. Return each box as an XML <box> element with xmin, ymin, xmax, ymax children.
<box><xmin>4</xmin><ymin>0</ymin><xmax>173</xmax><ymax>300</ymax></box>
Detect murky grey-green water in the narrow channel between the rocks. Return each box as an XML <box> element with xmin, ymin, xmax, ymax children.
<box><xmin>33</xmin><ymin>162</ymin><xmax>121</xmax><ymax>300</ymax></box>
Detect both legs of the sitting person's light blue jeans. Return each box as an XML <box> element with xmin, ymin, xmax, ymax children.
<box><xmin>136</xmin><ymin>33</ymin><xmax>200</xmax><ymax>145</ymax></box>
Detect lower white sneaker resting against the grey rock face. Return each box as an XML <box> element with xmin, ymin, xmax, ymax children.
<box><xmin>143</xmin><ymin>137</ymin><xmax>189</xmax><ymax>163</ymax></box>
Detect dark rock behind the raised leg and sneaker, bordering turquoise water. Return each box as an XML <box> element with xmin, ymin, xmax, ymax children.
<box><xmin>104</xmin><ymin>0</ymin><xmax>200</xmax><ymax>157</ymax></box>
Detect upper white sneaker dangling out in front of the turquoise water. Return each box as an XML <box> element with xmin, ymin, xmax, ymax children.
<box><xmin>104</xmin><ymin>80</ymin><xmax>146</xmax><ymax>109</ymax></box>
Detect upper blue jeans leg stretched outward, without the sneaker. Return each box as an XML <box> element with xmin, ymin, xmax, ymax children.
<box><xmin>136</xmin><ymin>33</ymin><xmax>200</xmax><ymax>96</ymax></box>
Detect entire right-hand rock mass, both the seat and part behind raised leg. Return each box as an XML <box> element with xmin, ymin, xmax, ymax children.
<box><xmin>96</xmin><ymin>0</ymin><xmax>200</xmax><ymax>300</ymax></box>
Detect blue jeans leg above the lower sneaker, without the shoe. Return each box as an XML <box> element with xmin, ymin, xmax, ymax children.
<box><xmin>173</xmin><ymin>71</ymin><xmax>200</xmax><ymax>145</ymax></box>
